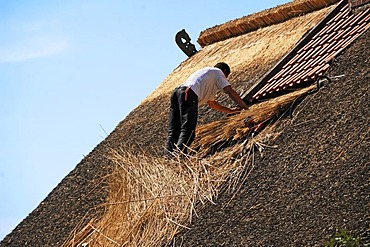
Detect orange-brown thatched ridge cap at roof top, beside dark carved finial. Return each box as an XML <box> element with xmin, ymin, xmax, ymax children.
<box><xmin>197</xmin><ymin>0</ymin><xmax>339</xmax><ymax>47</ymax></box>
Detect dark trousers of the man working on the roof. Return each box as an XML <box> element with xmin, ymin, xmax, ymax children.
<box><xmin>166</xmin><ymin>87</ymin><xmax>198</xmax><ymax>153</ymax></box>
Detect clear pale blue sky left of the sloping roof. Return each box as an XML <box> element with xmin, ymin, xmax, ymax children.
<box><xmin>0</xmin><ymin>0</ymin><xmax>288</xmax><ymax>240</ymax></box>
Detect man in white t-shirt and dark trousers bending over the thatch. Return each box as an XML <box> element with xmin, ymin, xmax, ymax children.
<box><xmin>166</xmin><ymin>63</ymin><xmax>248</xmax><ymax>153</ymax></box>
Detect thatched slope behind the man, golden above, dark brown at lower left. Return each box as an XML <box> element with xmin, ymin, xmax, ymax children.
<box><xmin>0</xmin><ymin>3</ymin><xmax>344</xmax><ymax>246</ymax></box>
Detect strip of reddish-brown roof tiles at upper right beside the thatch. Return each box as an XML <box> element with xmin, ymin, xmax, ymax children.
<box><xmin>244</xmin><ymin>1</ymin><xmax>370</xmax><ymax>102</ymax></box>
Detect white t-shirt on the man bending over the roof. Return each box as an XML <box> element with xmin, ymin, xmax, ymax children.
<box><xmin>182</xmin><ymin>67</ymin><xmax>230</xmax><ymax>105</ymax></box>
